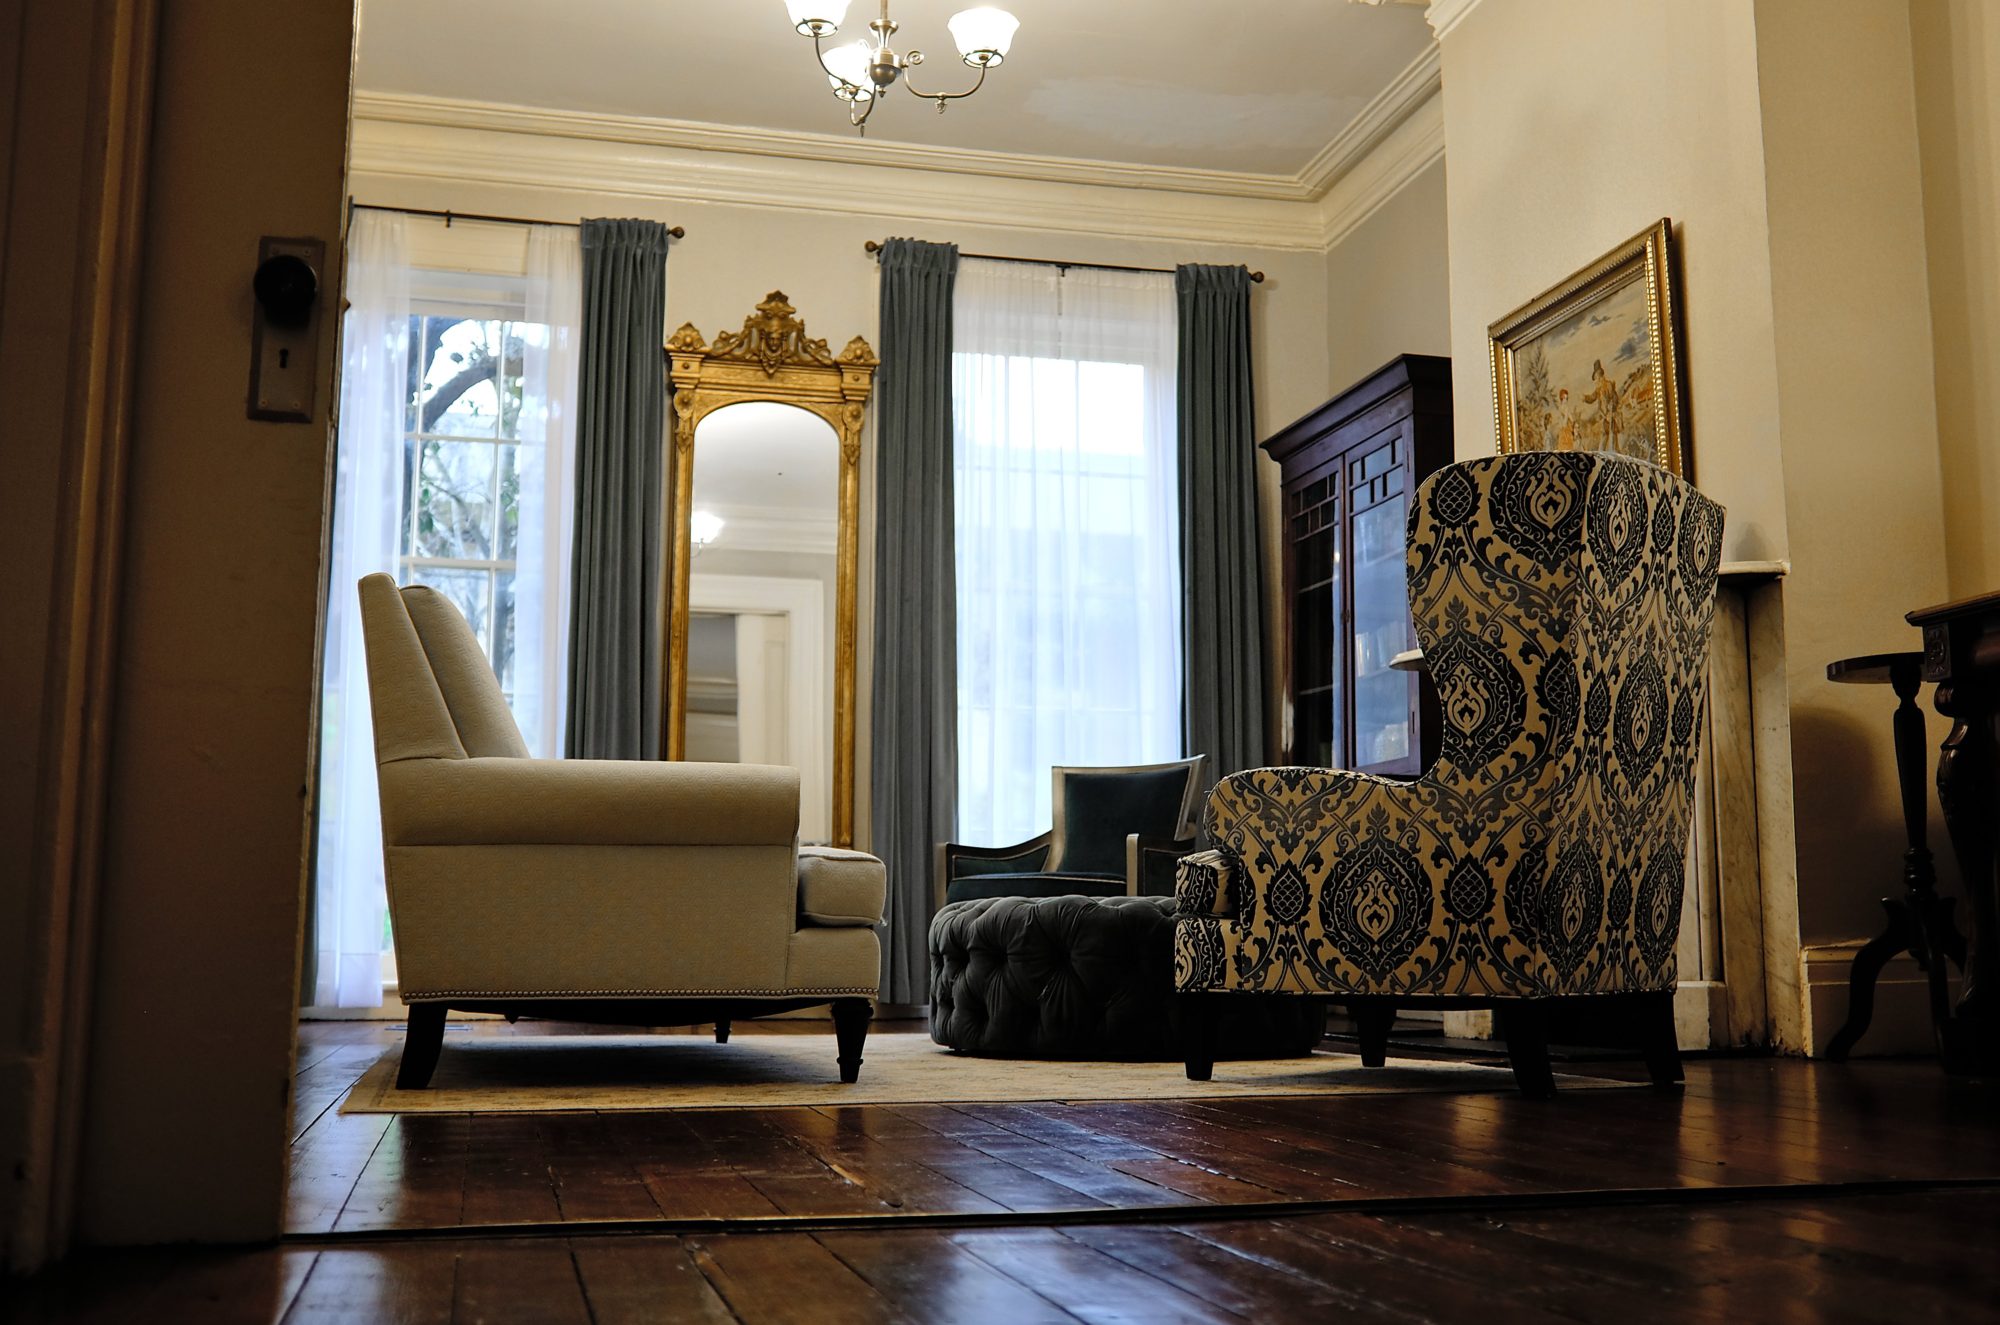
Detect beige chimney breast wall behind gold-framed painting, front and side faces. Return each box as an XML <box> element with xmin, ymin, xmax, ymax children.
<box><xmin>1442</xmin><ymin>0</ymin><xmax>1944</xmax><ymax>960</ymax></box>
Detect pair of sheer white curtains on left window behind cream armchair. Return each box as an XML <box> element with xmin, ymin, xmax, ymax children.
<box><xmin>310</xmin><ymin>220</ymin><xmax>582</xmax><ymax>1007</ymax></box>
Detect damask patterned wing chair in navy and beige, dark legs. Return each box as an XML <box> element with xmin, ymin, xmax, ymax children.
<box><xmin>1174</xmin><ymin>452</ymin><xmax>1722</xmax><ymax>1095</ymax></box>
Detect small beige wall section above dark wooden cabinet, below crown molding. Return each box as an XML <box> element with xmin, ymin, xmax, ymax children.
<box><xmin>1326</xmin><ymin>160</ymin><xmax>1452</xmax><ymax>396</ymax></box>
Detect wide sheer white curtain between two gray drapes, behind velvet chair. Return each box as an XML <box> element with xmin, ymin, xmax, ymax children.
<box><xmin>952</xmin><ymin>258</ymin><xmax>1182</xmax><ymax>845</ymax></box>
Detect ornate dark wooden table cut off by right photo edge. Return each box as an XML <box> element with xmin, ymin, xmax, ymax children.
<box><xmin>1908</xmin><ymin>592</ymin><xmax>2000</xmax><ymax>1077</ymax></box>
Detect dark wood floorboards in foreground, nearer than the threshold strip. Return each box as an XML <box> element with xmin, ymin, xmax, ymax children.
<box><xmin>27</xmin><ymin>1191</ymin><xmax>2000</xmax><ymax>1325</ymax></box>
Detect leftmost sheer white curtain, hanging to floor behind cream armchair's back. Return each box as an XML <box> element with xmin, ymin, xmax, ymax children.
<box><xmin>312</xmin><ymin>210</ymin><xmax>410</xmax><ymax>1007</ymax></box>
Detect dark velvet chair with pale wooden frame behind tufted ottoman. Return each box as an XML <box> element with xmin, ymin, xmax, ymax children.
<box><xmin>934</xmin><ymin>755</ymin><xmax>1208</xmax><ymax>907</ymax></box>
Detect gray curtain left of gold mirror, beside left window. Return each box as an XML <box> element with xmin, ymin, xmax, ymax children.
<box><xmin>564</xmin><ymin>220</ymin><xmax>668</xmax><ymax>759</ymax></box>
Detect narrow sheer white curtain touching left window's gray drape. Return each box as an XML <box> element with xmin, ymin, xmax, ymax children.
<box><xmin>514</xmin><ymin>226</ymin><xmax>584</xmax><ymax>759</ymax></box>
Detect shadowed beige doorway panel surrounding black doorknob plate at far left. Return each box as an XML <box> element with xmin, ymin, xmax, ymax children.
<box><xmin>78</xmin><ymin>0</ymin><xmax>352</xmax><ymax>1243</ymax></box>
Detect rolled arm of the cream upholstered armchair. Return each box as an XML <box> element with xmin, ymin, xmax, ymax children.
<box><xmin>376</xmin><ymin>759</ymin><xmax>798</xmax><ymax>847</ymax></box>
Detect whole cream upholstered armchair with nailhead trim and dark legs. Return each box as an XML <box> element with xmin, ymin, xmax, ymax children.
<box><xmin>360</xmin><ymin>574</ymin><xmax>884</xmax><ymax>1089</ymax></box>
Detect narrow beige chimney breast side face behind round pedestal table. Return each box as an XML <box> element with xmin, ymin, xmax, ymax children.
<box><xmin>1756</xmin><ymin>0</ymin><xmax>1950</xmax><ymax>945</ymax></box>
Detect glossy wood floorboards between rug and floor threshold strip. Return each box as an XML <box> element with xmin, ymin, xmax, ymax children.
<box><xmin>286</xmin><ymin>1023</ymin><xmax>2000</xmax><ymax>1233</ymax></box>
